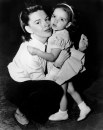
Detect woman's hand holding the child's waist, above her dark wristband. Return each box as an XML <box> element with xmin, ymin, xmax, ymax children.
<box><xmin>54</xmin><ymin>50</ymin><xmax>70</xmax><ymax>68</ymax></box>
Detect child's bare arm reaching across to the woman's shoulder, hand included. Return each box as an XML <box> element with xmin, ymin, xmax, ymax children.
<box><xmin>27</xmin><ymin>46</ymin><xmax>61</xmax><ymax>62</ymax></box>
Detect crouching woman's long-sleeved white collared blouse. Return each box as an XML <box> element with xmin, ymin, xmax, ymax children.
<box><xmin>8</xmin><ymin>34</ymin><xmax>55</xmax><ymax>82</ymax></box>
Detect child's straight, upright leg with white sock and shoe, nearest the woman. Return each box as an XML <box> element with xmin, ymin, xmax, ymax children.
<box><xmin>49</xmin><ymin>83</ymin><xmax>68</xmax><ymax>121</ymax></box>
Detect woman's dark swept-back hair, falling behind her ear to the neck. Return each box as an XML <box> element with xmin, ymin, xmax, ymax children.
<box><xmin>19</xmin><ymin>5</ymin><xmax>45</xmax><ymax>40</ymax></box>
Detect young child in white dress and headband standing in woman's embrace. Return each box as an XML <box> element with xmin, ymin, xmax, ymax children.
<box><xmin>28</xmin><ymin>3</ymin><xmax>91</xmax><ymax>121</ymax></box>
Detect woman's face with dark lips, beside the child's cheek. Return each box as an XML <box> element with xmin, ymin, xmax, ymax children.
<box><xmin>28</xmin><ymin>10</ymin><xmax>51</xmax><ymax>38</ymax></box>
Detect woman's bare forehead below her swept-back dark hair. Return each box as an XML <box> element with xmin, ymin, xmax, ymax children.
<box><xmin>29</xmin><ymin>10</ymin><xmax>47</xmax><ymax>21</ymax></box>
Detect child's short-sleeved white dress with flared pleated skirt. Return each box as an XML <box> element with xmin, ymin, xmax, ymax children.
<box><xmin>47</xmin><ymin>30</ymin><xmax>85</xmax><ymax>85</ymax></box>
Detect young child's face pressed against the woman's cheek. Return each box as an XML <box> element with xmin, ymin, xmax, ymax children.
<box><xmin>51</xmin><ymin>8</ymin><xmax>68</xmax><ymax>31</ymax></box>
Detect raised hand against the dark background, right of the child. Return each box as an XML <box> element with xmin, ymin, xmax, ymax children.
<box><xmin>79</xmin><ymin>34</ymin><xmax>88</xmax><ymax>52</ymax></box>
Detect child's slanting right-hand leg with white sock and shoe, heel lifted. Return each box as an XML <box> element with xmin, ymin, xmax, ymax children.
<box><xmin>67</xmin><ymin>82</ymin><xmax>91</xmax><ymax>121</ymax></box>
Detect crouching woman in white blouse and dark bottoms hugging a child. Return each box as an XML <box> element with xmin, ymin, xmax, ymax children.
<box><xmin>6</xmin><ymin>5</ymin><xmax>69</xmax><ymax>125</ymax></box>
